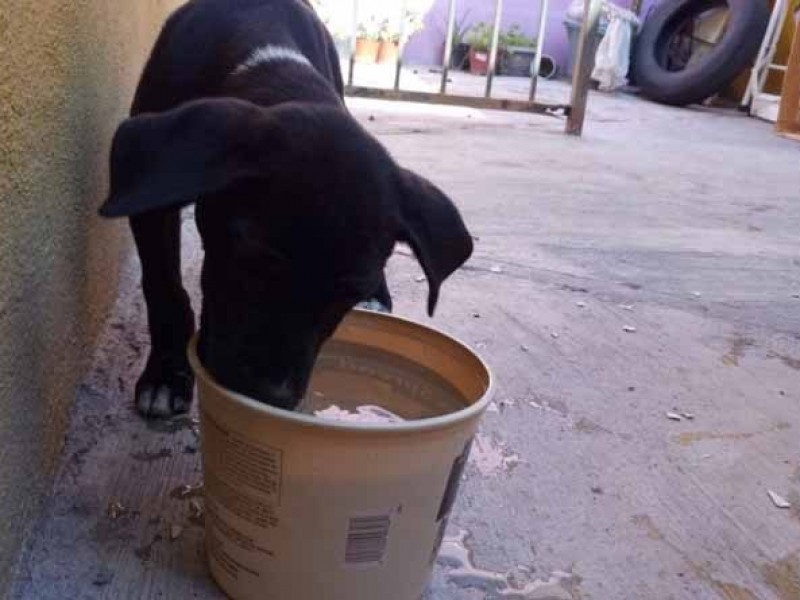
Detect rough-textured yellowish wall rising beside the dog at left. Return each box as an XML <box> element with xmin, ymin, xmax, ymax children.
<box><xmin>0</xmin><ymin>0</ymin><xmax>179</xmax><ymax>597</ymax></box>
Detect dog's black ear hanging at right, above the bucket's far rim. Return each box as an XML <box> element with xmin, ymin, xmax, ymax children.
<box><xmin>399</xmin><ymin>169</ymin><xmax>473</xmax><ymax>316</ymax></box>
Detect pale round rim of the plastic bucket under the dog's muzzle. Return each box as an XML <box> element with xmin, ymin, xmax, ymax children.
<box><xmin>187</xmin><ymin>308</ymin><xmax>495</xmax><ymax>434</ymax></box>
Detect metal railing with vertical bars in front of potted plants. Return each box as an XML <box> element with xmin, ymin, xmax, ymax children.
<box><xmin>346</xmin><ymin>0</ymin><xmax>603</xmax><ymax>135</ymax></box>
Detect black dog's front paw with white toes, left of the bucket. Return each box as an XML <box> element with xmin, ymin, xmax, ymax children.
<box><xmin>136</xmin><ymin>351</ymin><xmax>194</xmax><ymax>419</ymax></box>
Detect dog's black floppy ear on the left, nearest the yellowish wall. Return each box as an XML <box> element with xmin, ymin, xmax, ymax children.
<box><xmin>100</xmin><ymin>98</ymin><xmax>296</xmax><ymax>217</ymax></box>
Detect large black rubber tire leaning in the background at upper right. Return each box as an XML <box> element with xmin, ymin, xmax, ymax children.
<box><xmin>632</xmin><ymin>0</ymin><xmax>769</xmax><ymax>106</ymax></box>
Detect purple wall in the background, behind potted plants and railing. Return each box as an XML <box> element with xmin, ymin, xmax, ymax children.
<box><xmin>405</xmin><ymin>0</ymin><xmax>658</xmax><ymax>70</ymax></box>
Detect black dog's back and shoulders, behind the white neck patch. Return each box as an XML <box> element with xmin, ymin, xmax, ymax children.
<box><xmin>131</xmin><ymin>0</ymin><xmax>342</xmax><ymax>115</ymax></box>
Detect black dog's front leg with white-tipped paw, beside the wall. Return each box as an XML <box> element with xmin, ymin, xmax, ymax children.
<box><xmin>130</xmin><ymin>209</ymin><xmax>195</xmax><ymax>418</ymax></box>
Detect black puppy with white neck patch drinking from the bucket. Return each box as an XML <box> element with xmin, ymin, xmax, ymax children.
<box><xmin>101</xmin><ymin>0</ymin><xmax>472</xmax><ymax>417</ymax></box>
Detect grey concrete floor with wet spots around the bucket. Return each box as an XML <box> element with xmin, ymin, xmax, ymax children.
<box><xmin>13</xmin><ymin>76</ymin><xmax>800</xmax><ymax>600</ymax></box>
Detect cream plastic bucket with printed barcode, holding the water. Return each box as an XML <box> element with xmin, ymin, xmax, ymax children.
<box><xmin>189</xmin><ymin>311</ymin><xmax>492</xmax><ymax>600</ymax></box>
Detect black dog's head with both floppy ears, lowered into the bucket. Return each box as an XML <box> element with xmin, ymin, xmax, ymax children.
<box><xmin>101</xmin><ymin>99</ymin><xmax>472</xmax><ymax>409</ymax></box>
